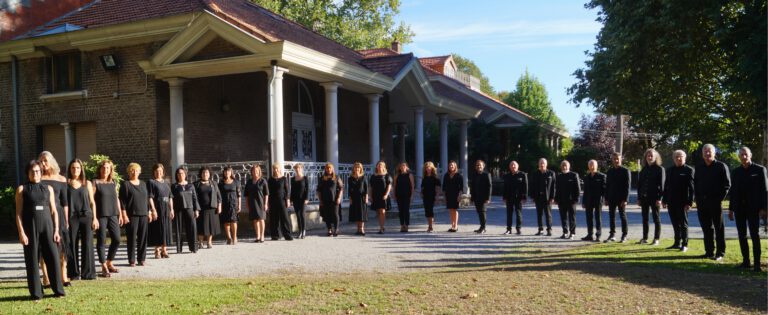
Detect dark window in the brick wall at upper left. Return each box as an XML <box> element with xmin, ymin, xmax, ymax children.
<box><xmin>48</xmin><ymin>52</ymin><xmax>83</xmax><ymax>93</ymax></box>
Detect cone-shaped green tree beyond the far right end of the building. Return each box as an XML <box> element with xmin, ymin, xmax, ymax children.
<box><xmin>504</xmin><ymin>70</ymin><xmax>564</xmax><ymax>128</ymax></box>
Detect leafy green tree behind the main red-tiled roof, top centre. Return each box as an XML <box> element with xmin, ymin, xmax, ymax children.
<box><xmin>251</xmin><ymin>0</ymin><xmax>414</xmax><ymax>49</ymax></box>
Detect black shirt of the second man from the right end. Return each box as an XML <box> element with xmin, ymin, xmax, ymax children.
<box><xmin>693</xmin><ymin>161</ymin><xmax>731</xmax><ymax>204</ymax></box>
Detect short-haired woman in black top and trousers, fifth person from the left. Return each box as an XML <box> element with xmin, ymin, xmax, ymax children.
<box><xmin>120</xmin><ymin>163</ymin><xmax>152</xmax><ymax>267</ymax></box>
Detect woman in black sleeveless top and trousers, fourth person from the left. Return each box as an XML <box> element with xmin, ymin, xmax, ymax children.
<box><xmin>93</xmin><ymin>160</ymin><xmax>121</xmax><ymax>277</ymax></box>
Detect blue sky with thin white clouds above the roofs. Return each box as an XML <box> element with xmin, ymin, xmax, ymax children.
<box><xmin>398</xmin><ymin>0</ymin><xmax>601</xmax><ymax>134</ymax></box>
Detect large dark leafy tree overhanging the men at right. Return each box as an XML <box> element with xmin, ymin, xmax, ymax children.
<box><xmin>568</xmin><ymin>0</ymin><xmax>768</xmax><ymax>163</ymax></box>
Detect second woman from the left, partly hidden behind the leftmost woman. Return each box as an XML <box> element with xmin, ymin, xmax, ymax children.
<box><xmin>37</xmin><ymin>151</ymin><xmax>74</xmax><ymax>286</ymax></box>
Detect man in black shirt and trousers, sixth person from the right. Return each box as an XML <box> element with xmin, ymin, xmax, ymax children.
<box><xmin>581</xmin><ymin>160</ymin><xmax>607</xmax><ymax>242</ymax></box>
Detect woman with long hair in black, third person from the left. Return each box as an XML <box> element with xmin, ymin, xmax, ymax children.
<box><xmin>67</xmin><ymin>159</ymin><xmax>99</xmax><ymax>280</ymax></box>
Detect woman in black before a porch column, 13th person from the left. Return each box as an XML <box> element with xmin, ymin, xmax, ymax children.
<box><xmin>316</xmin><ymin>163</ymin><xmax>344</xmax><ymax>236</ymax></box>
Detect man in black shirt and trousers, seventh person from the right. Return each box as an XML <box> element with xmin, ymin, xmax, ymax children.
<box><xmin>555</xmin><ymin>161</ymin><xmax>581</xmax><ymax>239</ymax></box>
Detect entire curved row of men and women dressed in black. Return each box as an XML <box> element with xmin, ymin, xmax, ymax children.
<box><xmin>16</xmin><ymin>144</ymin><xmax>768</xmax><ymax>299</ymax></box>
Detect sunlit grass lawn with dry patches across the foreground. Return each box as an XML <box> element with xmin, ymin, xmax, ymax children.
<box><xmin>0</xmin><ymin>240</ymin><xmax>768</xmax><ymax>314</ymax></box>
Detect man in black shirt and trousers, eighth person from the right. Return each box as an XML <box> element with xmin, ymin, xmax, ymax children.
<box><xmin>528</xmin><ymin>158</ymin><xmax>556</xmax><ymax>236</ymax></box>
